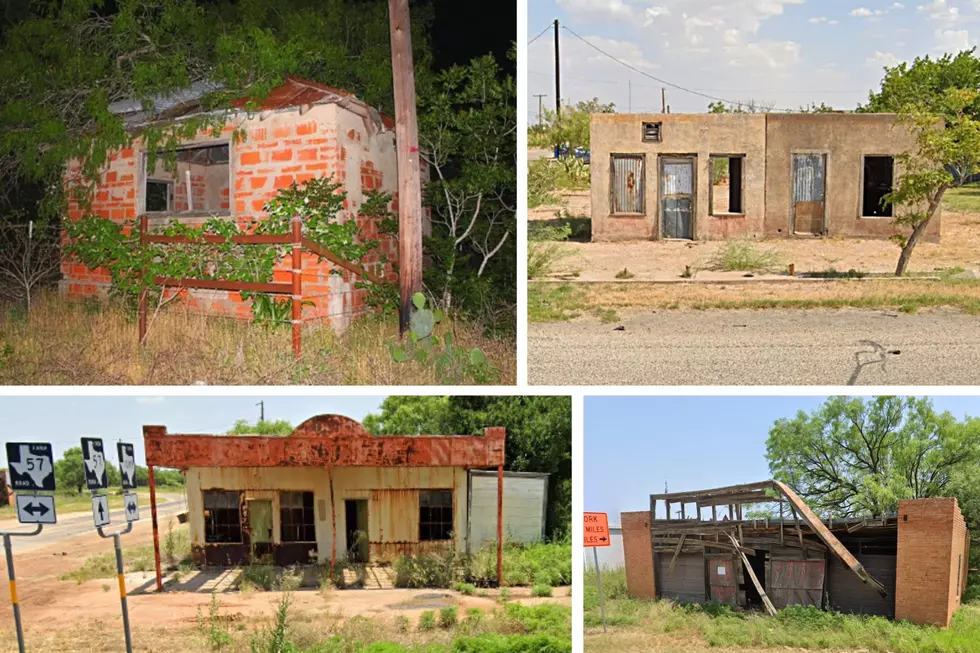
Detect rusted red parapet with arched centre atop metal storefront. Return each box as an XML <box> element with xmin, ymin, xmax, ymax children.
<box><xmin>143</xmin><ymin>415</ymin><xmax>506</xmax><ymax>469</ymax></box>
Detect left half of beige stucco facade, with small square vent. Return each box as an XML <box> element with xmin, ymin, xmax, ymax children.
<box><xmin>591</xmin><ymin>113</ymin><xmax>766</xmax><ymax>240</ymax></box>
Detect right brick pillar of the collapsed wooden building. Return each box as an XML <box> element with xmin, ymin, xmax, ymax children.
<box><xmin>895</xmin><ymin>499</ymin><xmax>968</xmax><ymax>627</ymax></box>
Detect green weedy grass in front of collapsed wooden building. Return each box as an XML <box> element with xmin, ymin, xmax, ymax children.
<box><xmin>583</xmin><ymin>568</ymin><xmax>980</xmax><ymax>653</ymax></box>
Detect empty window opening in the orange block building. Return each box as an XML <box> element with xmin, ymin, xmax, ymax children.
<box><xmin>143</xmin><ymin>143</ymin><xmax>231</xmax><ymax>215</ymax></box>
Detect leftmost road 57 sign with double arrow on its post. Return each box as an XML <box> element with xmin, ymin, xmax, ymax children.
<box><xmin>0</xmin><ymin>442</ymin><xmax>57</xmax><ymax>653</ymax></box>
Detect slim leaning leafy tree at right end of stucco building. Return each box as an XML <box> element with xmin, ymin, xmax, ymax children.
<box><xmin>883</xmin><ymin>89</ymin><xmax>980</xmax><ymax>277</ymax></box>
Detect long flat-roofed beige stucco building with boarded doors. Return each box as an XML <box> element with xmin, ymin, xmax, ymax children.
<box><xmin>591</xmin><ymin>113</ymin><xmax>940</xmax><ymax>241</ymax></box>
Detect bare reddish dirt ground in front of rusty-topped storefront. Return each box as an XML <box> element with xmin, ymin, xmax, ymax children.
<box><xmin>0</xmin><ymin>520</ymin><xmax>571</xmax><ymax>636</ymax></box>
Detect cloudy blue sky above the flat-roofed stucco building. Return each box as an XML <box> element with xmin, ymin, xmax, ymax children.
<box><xmin>527</xmin><ymin>0</ymin><xmax>980</xmax><ymax>121</ymax></box>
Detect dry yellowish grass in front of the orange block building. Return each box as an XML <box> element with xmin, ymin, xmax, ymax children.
<box><xmin>0</xmin><ymin>292</ymin><xmax>516</xmax><ymax>385</ymax></box>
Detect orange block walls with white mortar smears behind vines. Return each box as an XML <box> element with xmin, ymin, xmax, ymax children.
<box><xmin>61</xmin><ymin>104</ymin><xmax>398</xmax><ymax>329</ymax></box>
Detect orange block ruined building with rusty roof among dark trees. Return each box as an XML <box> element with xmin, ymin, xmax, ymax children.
<box><xmin>61</xmin><ymin>78</ymin><xmax>406</xmax><ymax>329</ymax></box>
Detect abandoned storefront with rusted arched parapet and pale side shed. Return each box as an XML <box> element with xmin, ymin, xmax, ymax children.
<box><xmin>143</xmin><ymin>415</ymin><xmax>548</xmax><ymax>584</ymax></box>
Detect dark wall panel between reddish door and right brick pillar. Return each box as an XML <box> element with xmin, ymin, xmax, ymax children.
<box><xmin>827</xmin><ymin>553</ymin><xmax>895</xmax><ymax>617</ymax></box>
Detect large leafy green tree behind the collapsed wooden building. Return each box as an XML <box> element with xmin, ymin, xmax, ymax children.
<box><xmin>766</xmin><ymin>397</ymin><xmax>980</xmax><ymax>517</ymax></box>
